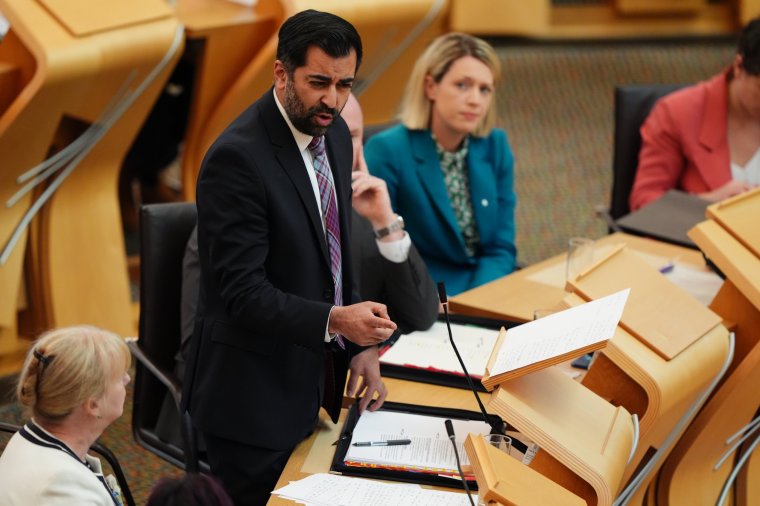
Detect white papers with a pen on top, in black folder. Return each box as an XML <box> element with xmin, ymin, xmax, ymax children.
<box><xmin>344</xmin><ymin>410</ymin><xmax>491</xmax><ymax>476</ymax></box>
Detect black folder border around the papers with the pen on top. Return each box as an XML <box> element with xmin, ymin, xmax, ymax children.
<box><xmin>330</xmin><ymin>402</ymin><xmax>503</xmax><ymax>490</ymax></box>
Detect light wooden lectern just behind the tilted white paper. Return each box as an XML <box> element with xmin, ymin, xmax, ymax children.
<box><xmin>566</xmin><ymin>249</ymin><xmax>730</xmax><ymax>504</ymax></box>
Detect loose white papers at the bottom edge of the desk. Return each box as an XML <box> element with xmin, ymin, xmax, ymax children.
<box><xmin>272</xmin><ymin>473</ymin><xmax>470</xmax><ymax>506</ymax></box>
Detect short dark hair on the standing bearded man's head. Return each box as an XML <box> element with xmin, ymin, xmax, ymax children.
<box><xmin>277</xmin><ymin>9</ymin><xmax>362</xmax><ymax>74</ymax></box>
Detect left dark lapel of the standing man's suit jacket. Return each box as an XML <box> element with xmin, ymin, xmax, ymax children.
<box><xmin>261</xmin><ymin>88</ymin><xmax>330</xmax><ymax>268</ymax></box>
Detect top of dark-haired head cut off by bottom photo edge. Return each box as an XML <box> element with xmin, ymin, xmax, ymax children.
<box><xmin>145</xmin><ymin>473</ymin><xmax>234</xmax><ymax>506</ymax></box>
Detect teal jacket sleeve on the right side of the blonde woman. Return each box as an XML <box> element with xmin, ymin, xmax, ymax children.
<box><xmin>471</xmin><ymin>130</ymin><xmax>517</xmax><ymax>286</ymax></box>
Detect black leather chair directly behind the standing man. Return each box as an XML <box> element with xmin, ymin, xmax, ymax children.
<box><xmin>128</xmin><ymin>202</ymin><xmax>207</xmax><ymax>472</ymax></box>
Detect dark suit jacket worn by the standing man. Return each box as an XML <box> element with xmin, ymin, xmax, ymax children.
<box><xmin>183</xmin><ymin>89</ymin><xmax>357</xmax><ymax>450</ymax></box>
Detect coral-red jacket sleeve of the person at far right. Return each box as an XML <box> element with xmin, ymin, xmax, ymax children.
<box><xmin>629</xmin><ymin>100</ymin><xmax>686</xmax><ymax>211</ymax></box>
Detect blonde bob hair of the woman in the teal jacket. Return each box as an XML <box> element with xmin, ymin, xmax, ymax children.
<box><xmin>400</xmin><ymin>32</ymin><xmax>501</xmax><ymax>137</ymax></box>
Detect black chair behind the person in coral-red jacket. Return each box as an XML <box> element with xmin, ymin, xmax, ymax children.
<box><xmin>600</xmin><ymin>84</ymin><xmax>684</xmax><ymax>231</ymax></box>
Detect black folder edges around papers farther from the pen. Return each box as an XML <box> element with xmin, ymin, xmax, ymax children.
<box><xmin>380</xmin><ymin>314</ymin><xmax>521</xmax><ymax>393</ymax></box>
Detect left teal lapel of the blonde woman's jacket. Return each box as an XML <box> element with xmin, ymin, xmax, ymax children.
<box><xmin>409</xmin><ymin>130</ymin><xmax>464</xmax><ymax>242</ymax></box>
